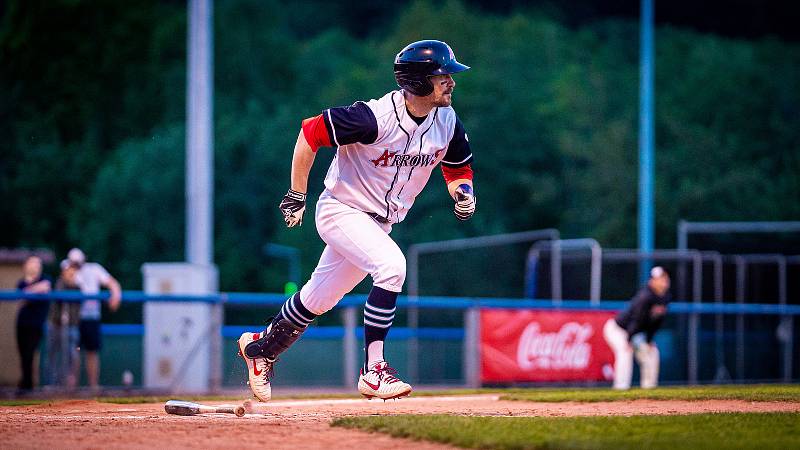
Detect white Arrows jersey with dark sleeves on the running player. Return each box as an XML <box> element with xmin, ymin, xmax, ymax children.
<box><xmin>322</xmin><ymin>91</ymin><xmax>472</xmax><ymax>223</ymax></box>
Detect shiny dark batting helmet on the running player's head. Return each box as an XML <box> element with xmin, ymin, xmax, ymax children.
<box><xmin>394</xmin><ymin>40</ymin><xmax>469</xmax><ymax>97</ymax></box>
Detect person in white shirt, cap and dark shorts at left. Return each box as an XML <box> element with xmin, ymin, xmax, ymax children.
<box><xmin>67</xmin><ymin>248</ymin><xmax>122</xmax><ymax>390</ymax></box>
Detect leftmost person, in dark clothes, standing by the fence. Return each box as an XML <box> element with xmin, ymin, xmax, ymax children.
<box><xmin>17</xmin><ymin>256</ymin><xmax>52</xmax><ymax>392</ymax></box>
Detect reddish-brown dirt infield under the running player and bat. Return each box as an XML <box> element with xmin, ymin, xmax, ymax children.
<box><xmin>0</xmin><ymin>395</ymin><xmax>800</xmax><ymax>449</ymax></box>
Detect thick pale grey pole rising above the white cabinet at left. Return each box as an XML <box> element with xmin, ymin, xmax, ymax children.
<box><xmin>186</xmin><ymin>0</ymin><xmax>214</xmax><ymax>266</ymax></box>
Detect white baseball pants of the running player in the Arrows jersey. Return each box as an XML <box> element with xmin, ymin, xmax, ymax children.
<box><xmin>300</xmin><ymin>193</ymin><xmax>406</xmax><ymax>315</ymax></box>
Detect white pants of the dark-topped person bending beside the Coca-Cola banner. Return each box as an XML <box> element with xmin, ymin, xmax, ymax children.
<box><xmin>603</xmin><ymin>318</ymin><xmax>660</xmax><ymax>389</ymax></box>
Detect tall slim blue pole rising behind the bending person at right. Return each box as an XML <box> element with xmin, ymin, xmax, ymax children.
<box><xmin>639</xmin><ymin>0</ymin><xmax>655</xmax><ymax>282</ymax></box>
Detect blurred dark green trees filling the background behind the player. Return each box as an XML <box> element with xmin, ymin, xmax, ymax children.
<box><xmin>0</xmin><ymin>0</ymin><xmax>800</xmax><ymax>291</ymax></box>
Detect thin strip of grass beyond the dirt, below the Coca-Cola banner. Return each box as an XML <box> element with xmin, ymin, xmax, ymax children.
<box><xmin>501</xmin><ymin>385</ymin><xmax>800</xmax><ymax>402</ymax></box>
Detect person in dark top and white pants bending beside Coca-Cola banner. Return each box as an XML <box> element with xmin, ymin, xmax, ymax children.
<box><xmin>603</xmin><ymin>266</ymin><xmax>670</xmax><ymax>389</ymax></box>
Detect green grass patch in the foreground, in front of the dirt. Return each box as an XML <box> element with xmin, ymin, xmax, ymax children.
<box><xmin>333</xmin><ymin>413</ymin><xmax>800</xmax><ymax>450</ymax></box>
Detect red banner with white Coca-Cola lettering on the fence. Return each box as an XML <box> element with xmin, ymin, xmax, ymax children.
<box><xmin>480</xmin><ymin>309</ymin><xmax>614</xmax><ymax>382</ymax></box>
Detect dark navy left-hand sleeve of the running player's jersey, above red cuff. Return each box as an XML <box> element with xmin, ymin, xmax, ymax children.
<box><xmin>322</xmin><ymin>102</ymin><xmax>378</xmax><ymax>146</ymax></box>
